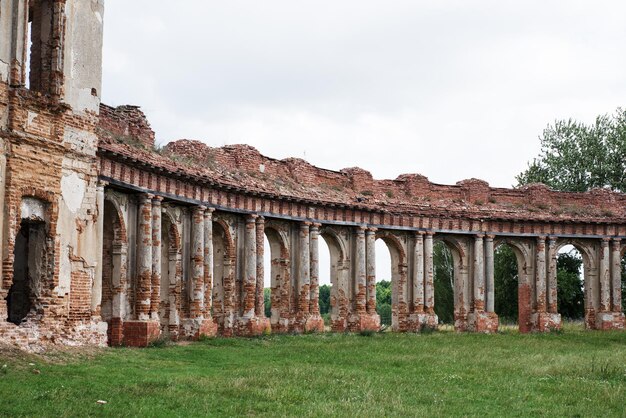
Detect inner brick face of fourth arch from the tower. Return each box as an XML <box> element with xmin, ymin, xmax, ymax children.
<box><xmin>265</xmin><ymin>222</ymin><xmax>292</xmax><ymax>332</ymax></box>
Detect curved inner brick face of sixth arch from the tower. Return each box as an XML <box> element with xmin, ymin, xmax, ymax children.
<box><xmin>376</xmin><ymin>231</ymin><xmax>410</xmax><ymax>331</ymax></box>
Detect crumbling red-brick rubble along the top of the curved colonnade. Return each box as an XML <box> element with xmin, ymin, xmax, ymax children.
<box><xmin>98</xmin><ymin>105</ymin><xmax>626</xmax><ymax>221</ymax></box>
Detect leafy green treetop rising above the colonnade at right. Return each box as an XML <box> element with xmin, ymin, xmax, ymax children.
<box><xmin>517</xmin><ymin>109</ymin><xmax>626</xmax><ymax>192</ymax></box>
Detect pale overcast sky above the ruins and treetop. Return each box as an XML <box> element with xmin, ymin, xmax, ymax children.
<box><xmin>103</xmin><ymin>0</ymin><xmax>626</xmax><ymax>286</ymax></box>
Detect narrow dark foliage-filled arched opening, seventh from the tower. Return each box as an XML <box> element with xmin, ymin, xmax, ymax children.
<box><xmin>433</xmin><ymin>240</ymin><xmax>455</xmax><ymax>330</ymax></box>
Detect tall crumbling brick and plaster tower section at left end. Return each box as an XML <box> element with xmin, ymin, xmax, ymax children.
<box><xmin>0</xmin><ymin>0</ymin><xmax>106</xmax><ymax>345</ymax></box>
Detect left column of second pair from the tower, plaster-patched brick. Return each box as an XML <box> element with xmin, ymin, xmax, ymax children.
<box><xmin>189</xmin><ymin>206</ymin><xmax>206</xmax><ymax>318</ymax></box>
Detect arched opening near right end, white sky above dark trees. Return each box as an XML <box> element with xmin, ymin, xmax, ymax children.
<box><xmin>557</xmin><ymin>243</ymin><xmax>584</xmax><ymax>326</ymax></box>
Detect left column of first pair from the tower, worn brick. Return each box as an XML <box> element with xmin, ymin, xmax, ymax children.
<box><xmin>135</xmin><ymin>194</ymin><xmax>154</xmax><ymax>321</ymax></box>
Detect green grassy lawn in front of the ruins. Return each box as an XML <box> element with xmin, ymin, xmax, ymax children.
<box><xmin>0</xmin><ymin>330</ymin><xmax>626</xmax><ymax>416</ymax></box>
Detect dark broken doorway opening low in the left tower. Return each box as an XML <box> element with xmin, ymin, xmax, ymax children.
<box><xmin>6</xmin><ymin>219</ymin><xmax>47</xmax><ymax>325</ymax></box>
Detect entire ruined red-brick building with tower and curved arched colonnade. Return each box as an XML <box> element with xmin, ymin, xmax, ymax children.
<box><xmin>0</xmin><ymin>0</ymin><xmax>626</xmax><ymax>346</ymax></box>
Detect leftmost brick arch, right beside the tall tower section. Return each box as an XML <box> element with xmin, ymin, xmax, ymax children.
<box><xmin>100</xmin><ymin>198</ymin><xmax>129</xmax><ymax>345</ymax></box>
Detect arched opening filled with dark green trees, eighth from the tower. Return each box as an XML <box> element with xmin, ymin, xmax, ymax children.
<box><xmin>493</xmin><ymin>242</ymin><xmax>525</xmax><ymax>330</ymax></box>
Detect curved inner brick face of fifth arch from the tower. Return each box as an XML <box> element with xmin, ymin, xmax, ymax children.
<box><xmin>320</xmin><ymin>227</ymin><xmax>350</xmax><ymax>332</ymax></box>
